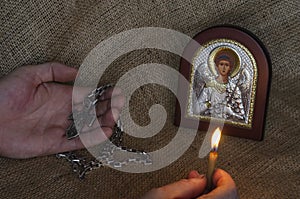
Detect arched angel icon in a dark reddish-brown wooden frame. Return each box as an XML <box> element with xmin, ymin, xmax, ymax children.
<box><xmin>175</xmin><ymin>27</ymin><xmax>269</xmax><ymax>140</ymax></box>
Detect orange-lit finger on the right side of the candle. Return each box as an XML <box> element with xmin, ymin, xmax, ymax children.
<box><xmin>199</xmin><ymin>169</ymin><xmax>238</xmax><ymax>199</ymax></box>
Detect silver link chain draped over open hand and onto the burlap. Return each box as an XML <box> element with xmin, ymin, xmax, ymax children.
<box><xmin>56</xmin><ymin>85</ymin><xmax>152</xmax><ymax>179</ymax></box>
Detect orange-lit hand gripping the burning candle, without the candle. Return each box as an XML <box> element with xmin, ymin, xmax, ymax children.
<box><xmin>143</xmin><ymin>169</ymin><xmax>238</xmax><ymax>199</ymax></box>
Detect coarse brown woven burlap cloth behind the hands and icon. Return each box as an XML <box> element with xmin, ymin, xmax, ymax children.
<box><xmin>0</xmin><ymin>0</ymin><xmax>300</xmax><ymax>199</ymax></box>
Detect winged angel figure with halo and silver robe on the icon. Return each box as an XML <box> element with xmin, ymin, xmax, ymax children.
<box><xmin>192</xmin><ymin>46</ymin><xmax>247</xmax><ymax>122</ymax></box>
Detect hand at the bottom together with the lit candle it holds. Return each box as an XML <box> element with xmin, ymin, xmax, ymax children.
<box><xmin>143</xmin><ymin>128</ymin><xmax>239</xmax><ymax>199</ymax></box>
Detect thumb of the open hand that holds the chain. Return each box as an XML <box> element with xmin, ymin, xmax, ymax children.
<box><xmin>21</xmin><ymin>62</ymin><xmax>78</xmax><ymax>85</ymax></box>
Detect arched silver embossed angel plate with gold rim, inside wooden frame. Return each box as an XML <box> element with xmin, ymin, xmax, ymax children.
<box><xmin>187</xmin><ymin>39</ymin><xmax>257</xmax><ymax>128</ymax></box>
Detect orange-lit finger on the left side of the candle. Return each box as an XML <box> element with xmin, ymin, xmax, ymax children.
<box><xmin>143</xmin><ymin>171</ymin><xmax>206</xmax><ymax>199</ymax></box>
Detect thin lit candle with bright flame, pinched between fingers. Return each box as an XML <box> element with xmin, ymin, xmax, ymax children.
<box><xmin>207</xmin><ymin>128</ymin><xmax>221</xmax><ymax>191</ymax></box>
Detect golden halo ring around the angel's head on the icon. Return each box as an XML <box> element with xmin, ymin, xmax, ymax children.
<box><xmin>208</xmin><ymin>46</ymin><xmax>241</xmax><ymax>77</ymax></box>
